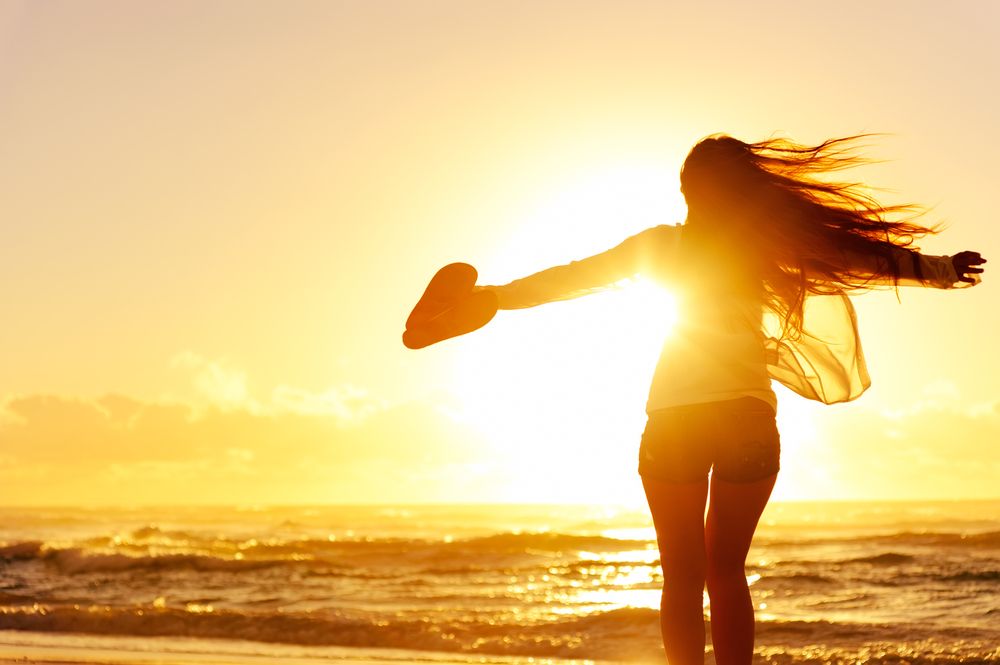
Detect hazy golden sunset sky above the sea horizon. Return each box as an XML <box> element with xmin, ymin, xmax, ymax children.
<box><xmin>0</xmin><ymin>0</ymin><xmax>1000</xmax><ymax>505</ymax></box>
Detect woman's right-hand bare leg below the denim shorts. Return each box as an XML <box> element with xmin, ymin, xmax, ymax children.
<box><xmin>705</xmin><ymin>475</ymin><xmax>777</xmax><ymax>665</ymax></box>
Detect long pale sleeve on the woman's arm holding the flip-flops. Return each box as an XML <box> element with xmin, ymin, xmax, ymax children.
<box><xmin>476</xmin><ymin>224</ymin><xmax>681</xmax><ymax>309</ymax></box>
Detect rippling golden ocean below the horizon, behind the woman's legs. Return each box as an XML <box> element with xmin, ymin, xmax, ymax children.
<box><xmin>0</xmin><ymin>501</ymin><xmax>1000</xmax><ymax>665</ymax></box>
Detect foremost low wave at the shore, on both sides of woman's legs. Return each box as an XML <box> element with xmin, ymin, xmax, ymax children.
<box><xmin>0</xmin><ymin>605</ymin><xmax>1000</xmax><ymax>665</ymax></box>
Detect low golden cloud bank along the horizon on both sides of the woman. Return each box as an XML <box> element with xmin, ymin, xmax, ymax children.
<box><xmin>0</xmin><ymin>352</ymin><xmax>1000</xmax><ymax>505</ymax></box>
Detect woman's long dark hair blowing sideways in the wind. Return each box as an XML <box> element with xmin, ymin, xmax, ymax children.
<box><xmin>681</xmin><ymin>135</ymin><xmax>938</xmax><ymax>337</ymax></box>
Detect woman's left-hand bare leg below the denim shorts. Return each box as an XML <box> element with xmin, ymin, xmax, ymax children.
<box><xmin>642</xmin><ymin>478</ymin><xmax>708</xmax><ymax>665</ymax></box>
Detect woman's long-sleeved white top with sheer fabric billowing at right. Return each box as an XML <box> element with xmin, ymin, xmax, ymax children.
<box><xmin>477</xmin><ymin>225</ymin><xmax>970</xmax><ymax>413</ymax></box>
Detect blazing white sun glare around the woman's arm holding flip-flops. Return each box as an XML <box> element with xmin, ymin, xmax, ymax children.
<box><xmin>449</xmin><ymin>165</ymin><xmax>683</xmax><ymax>503</ymax></box>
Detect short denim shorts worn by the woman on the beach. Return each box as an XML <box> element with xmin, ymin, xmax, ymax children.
<box><xmin>639</xmin><ymin>397</ymin><xmax>781</xmax><ymax>483</ymax></box>
